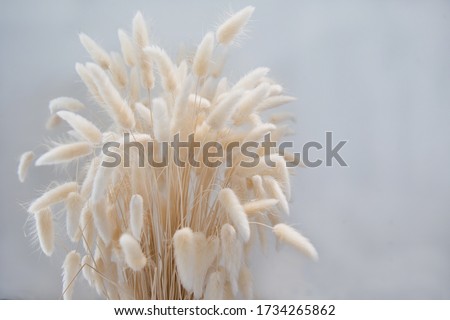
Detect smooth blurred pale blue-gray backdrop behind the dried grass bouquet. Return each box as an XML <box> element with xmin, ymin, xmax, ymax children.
<box><xmin>0</xmin><ymin>0</ymin><xmax>450</xmax><ymax>299</ymax></box>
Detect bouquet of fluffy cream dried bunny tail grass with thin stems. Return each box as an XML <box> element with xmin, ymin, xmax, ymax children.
<box><xmin>18</xmin><ymin>7</ymin><xmax>317</xmax><ymax>299</ymax></box>
